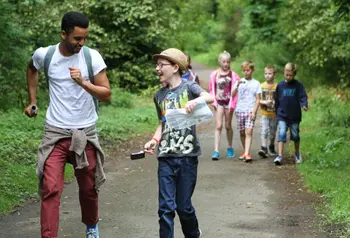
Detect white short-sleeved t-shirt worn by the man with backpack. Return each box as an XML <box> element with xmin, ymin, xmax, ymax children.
<box><xmin>32</xmin><ymin>44</ymin><xmax>107</xmax><ymax>129</ymax></box>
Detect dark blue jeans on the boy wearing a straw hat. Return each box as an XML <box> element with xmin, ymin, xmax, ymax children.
<box><xmin>158</xmin><ymin>157</ymin><xmax>199</xmax><ymax>238</ymax></box>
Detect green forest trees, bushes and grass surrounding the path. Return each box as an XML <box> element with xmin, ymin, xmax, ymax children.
<box><xmin>0</xmin><ymin>0</ymin><xmax>350</xmax><ymax>235</ymax></box>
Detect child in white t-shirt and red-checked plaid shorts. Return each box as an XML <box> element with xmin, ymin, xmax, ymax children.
<box><xmin>232</xmin><ymin>61</ymin><xmax>261</xmax><ymax>162</ymax></box>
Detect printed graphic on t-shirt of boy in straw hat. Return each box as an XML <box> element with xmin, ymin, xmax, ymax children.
<box><xmin>159</xmin><ymin>90</ymin><xmax>195</xmax><ymax>156</ymax></box>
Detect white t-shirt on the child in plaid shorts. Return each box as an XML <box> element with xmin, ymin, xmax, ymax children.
<box><xmin>234</xmin><ymin>78</ymin><xmax>261</xmax><ymax>112</ymax></box>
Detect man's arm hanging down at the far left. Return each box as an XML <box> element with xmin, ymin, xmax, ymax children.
<box><xmin>24</xmin><ymin>59</ymin><xmax>38</xmax><ymax>117</ymax></box>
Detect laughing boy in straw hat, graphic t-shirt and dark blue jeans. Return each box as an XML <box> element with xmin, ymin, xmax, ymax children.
<box><xmin>144</xmin><ymin>48</ymin><xmax>213</xmax><ymax>238</ymax></box>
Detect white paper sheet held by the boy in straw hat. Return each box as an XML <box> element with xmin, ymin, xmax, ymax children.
<box><xmin>165</xmin><ymin>99</ymin><xmax>213</xmax><ymax>130</ymax></box>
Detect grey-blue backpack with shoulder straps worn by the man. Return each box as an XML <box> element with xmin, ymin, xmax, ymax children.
<box><xmin>44</xmin><ymin>45</ymin><xmax>98</xmax><ymax>114</ymax></box>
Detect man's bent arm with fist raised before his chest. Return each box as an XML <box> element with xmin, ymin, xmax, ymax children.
<box><xmin>69</xmin><ymin>68</ymin><xmax>112</xmax><ymax>102</ymax></box>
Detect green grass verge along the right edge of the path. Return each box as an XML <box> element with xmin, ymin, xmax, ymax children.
<box><xmin>298</xmin><ymin>88</ymin><xmax>350</xmax><ymax>237</ymax></box>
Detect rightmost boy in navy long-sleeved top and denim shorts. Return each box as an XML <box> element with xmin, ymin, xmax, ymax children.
<box><xmin>274</xmin><ymin>63</ymin><xmax>308</xmax><ymax>165</ymax></box>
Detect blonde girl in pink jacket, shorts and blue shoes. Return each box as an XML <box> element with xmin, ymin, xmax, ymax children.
<box><xmin>209</xmin><ymin>51</ymin><xmax>239</xmax><ymax>160</ymax></box>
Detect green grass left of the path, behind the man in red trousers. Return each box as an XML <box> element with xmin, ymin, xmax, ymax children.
<box><xmin>0</xmin><ymin>89</ymin><xmax>158</xmax><ymax>215</ymax></box>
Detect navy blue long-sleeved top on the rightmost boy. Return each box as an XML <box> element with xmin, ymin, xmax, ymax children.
<box><xmin>275</xmin><ymin>79</ymin><xmax>308</xmax><ymax>123</ymax></box>
